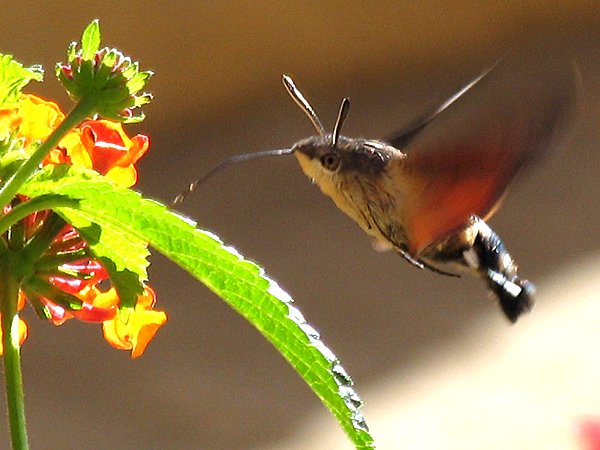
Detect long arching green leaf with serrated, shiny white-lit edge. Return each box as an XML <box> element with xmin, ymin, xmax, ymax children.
<box><xmin>21</xmin><ymin>167</ymin><xmax>373</xmax><ymax>448</ymax></box>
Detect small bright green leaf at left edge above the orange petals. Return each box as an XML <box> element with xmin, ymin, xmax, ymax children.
<box><xmin>0</xmin><ymin>54</ymin><xmax>44</xmax><ymax>106</ymax></box>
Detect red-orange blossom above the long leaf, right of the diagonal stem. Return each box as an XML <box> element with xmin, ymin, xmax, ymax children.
<box><xmin>52</xmin><ymin>120</ymin><xmax>150</xmax><ymax>187</ymax></box>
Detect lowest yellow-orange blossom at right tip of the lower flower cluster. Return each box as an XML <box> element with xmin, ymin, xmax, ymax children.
<box><xmin>102</xmin><ymin>286</ymin><xmax>167</xmax><ymax>358</ymax></box>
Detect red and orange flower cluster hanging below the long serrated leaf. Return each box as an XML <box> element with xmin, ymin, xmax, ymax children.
<box><xmin>21</xmin><ymin>213</ymin><xmax>167</xmax><ymax>358</ymax></box>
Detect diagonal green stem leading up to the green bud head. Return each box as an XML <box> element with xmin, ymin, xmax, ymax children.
<box><xmin>0</xmin><ymin>96</ymin><xmax>96</xmax><ymax>211</ymax></box>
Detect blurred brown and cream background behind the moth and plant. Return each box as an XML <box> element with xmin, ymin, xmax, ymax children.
<box><xmin>0</xmin><ymin>0</ymin><xmax>600</xmax><ymax>450</ymax></box>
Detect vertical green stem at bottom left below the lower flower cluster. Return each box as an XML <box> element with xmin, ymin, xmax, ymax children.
<box><xmin>0</xmin><ymin>254</ymin><xmax>29</xmax><ymax>450</ymax></box>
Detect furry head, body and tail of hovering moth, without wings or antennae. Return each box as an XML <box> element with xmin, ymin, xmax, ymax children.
<box><xmin>292</xmin><ymin>135</ymin><xmax>535</xmax><ymax>322</ymax></box>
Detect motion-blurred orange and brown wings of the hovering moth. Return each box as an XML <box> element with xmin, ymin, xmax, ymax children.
<box><xmin>391</xmin><ymin>50</ymin><xmax>577</xmax><ymax>255</ymax></box>
